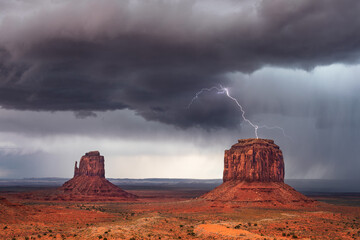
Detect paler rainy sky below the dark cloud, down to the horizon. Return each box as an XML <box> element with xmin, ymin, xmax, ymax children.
<box><xmin>0</xmin><ymin>64</ymin><xmax>360</xmax><ymax>179</ymax></box>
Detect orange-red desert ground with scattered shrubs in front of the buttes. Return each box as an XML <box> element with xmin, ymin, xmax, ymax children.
<box><xmin>0</xmin><ymin>189</ymin><xmax>360</xmax><ymax>239</ymax></box>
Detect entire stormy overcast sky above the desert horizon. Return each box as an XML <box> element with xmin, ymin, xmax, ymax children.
<box><xmin>0</xmin><ymin>0</ymin><xmax>360</xmax><ymax>179</ymax></box>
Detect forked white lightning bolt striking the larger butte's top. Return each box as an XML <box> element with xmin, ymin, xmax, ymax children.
<box><xmin>187</xmin><ymin>85</ymin><xmax>291</xmax><ymax>139</ymax></box>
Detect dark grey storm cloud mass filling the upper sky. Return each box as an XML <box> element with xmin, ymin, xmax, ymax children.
<box><xmin>0</xmin><ymin>0</ymin><xmax>360</xmax><ymax>127</ymax></box>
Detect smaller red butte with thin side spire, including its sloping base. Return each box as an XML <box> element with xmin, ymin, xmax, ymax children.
<box><xmin>60</xmin><ymin>151</ymin><xmax>137</xmax><ymax>200</ymax></box>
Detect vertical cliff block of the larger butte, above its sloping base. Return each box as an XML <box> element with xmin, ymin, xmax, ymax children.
<box><xmin>223</xmin><ymin>139</ymin><xmax>284</xmax><ymax>182</ymax></box>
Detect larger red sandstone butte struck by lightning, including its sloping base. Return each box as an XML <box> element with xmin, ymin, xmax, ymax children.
<box><xmin>202</xmin><ymin>138</ymin><xmax>313</xmax><ymax>206</ymax></box>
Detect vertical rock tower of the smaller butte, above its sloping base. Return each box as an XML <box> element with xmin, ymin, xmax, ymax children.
<box><xmin>74</xmin><ymin>151</ymin><xmax>105</xmax><ymax>178</ymax></box>
